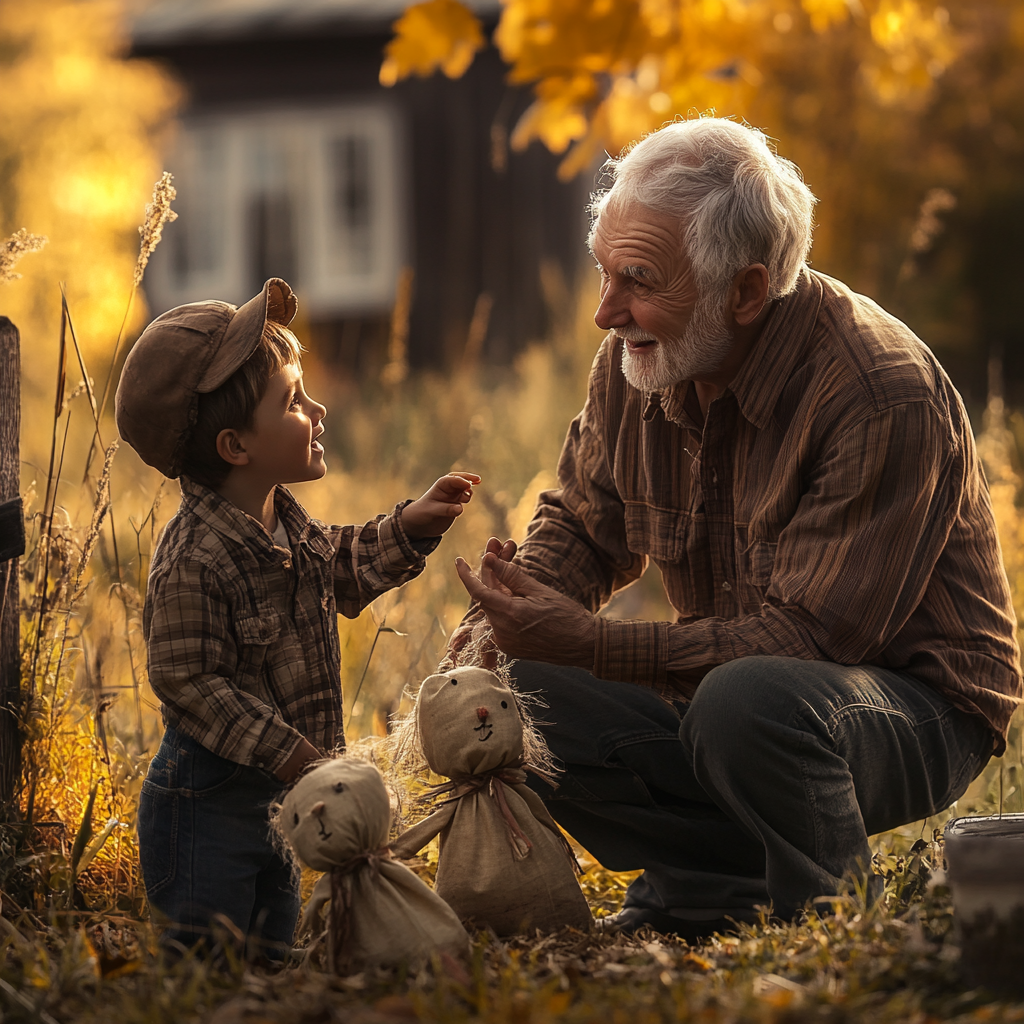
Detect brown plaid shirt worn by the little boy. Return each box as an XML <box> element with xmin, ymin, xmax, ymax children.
<box><xmin>143</xmin><ymin>477</ymin><xmax>437</xmax><ymax>771</ymax></box>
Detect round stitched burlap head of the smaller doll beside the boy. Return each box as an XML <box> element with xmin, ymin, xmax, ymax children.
<box><xmin>279</xmin><ymin>758</ymin><xmax>391</xmax><ymax>871</ymax></box>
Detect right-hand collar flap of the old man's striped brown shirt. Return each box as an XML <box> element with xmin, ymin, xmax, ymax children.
<box><xmin>729</xmin><ymin>267</ymin><xmax>823</xmax><ymax>430</ymax></box>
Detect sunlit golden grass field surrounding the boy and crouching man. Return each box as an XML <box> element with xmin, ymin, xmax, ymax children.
<box><xmin>0</xmin><ymin>192</ymin><xmax>1024</xmax><ymax>1021</ymax></box>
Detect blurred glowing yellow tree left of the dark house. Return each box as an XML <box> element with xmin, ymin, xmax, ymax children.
<box><xmin>0</xmin><ymin>0</ymin><xmax>177</xmax><ymax>421</ymax></box>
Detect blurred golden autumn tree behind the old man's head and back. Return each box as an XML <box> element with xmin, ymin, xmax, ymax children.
<box><xmin>381</xmin><ymin>0</ymin><xmax>1024</xmax><ymax>403</ymax></box>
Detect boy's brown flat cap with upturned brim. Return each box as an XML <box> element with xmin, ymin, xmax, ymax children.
<box><xmin>114</xmin><ymin>278</ymin><xmax>298</xmax><ymax>479</ymax></box>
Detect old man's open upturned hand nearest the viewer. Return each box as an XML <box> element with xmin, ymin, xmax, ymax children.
<box><xmin>455</xmin><ymin>550</ymin><xmax>596</xmax><ymax>669</ymax></box>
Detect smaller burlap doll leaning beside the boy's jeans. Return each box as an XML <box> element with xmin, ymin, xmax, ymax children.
<box><xmin>274</xmin><ymin>757</ymin><xmax>469</xmax><ymax>974</ymax></box>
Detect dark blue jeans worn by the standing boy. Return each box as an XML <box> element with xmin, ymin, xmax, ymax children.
<box><xmin>138</xmin><ymin>727</ymin><xmax>299</xmax><ymax>959</ymax></box>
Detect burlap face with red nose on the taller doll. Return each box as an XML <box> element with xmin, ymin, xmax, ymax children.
<box><xmin>417</xmin><ymin>668</ymin><xmax>522</xmax><ymax>776</ymax></box>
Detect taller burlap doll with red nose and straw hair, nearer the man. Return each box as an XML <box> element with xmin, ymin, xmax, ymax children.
<box><xmin>392</xmin><ymin>668</ymin><xmax>592</xmax><ymax>936</ymax></box>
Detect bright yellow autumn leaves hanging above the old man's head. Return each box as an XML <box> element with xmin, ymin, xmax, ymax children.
<box><xmin>381</xmin><ymin>0</ymin><xmax>955</xmax><ymax>177</ymax></box>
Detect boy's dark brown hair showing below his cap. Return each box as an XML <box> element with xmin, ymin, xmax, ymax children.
<box><xmin>181</xmin><ymin>319</ymin><xmax>302</xmax><ymax>487</ymax></box>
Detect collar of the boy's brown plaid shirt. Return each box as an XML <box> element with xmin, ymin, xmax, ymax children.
<box><xmin>178</xmin><ymin>475</ymin><xmax>334</xmax><ymax>561</ymax></box>
